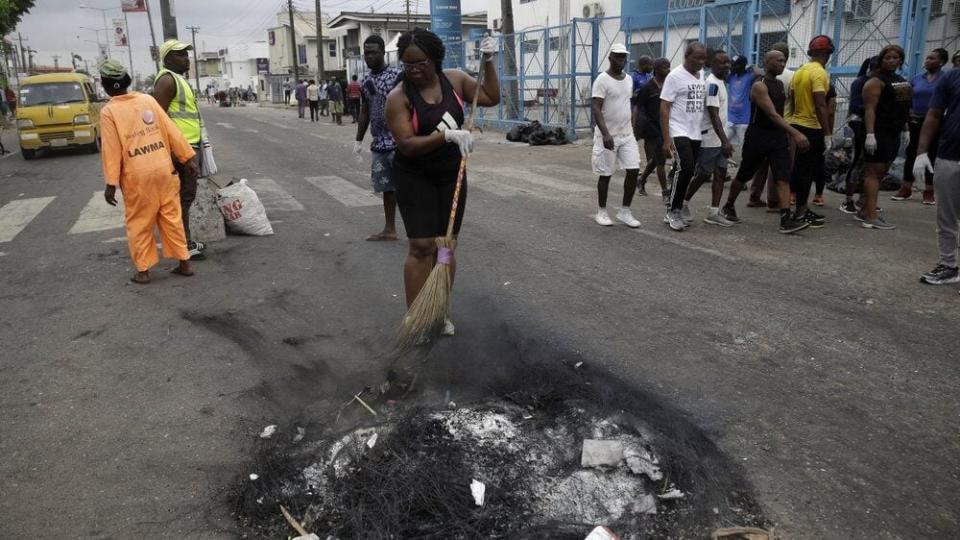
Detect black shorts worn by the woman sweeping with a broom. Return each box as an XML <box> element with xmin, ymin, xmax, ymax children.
<box><xmin>393</xmin><ymin>161</ymin><xmax>467</xmax><ymax>238</ymax></box>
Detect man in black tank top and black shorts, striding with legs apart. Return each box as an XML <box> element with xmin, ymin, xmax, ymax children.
<box><xmin>723</xmin><ymin>50</ymin><xmax>810</xmax><ymax>234</ymax></box>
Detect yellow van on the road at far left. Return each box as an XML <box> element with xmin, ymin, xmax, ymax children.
<box><xmin>17</xmin><ymin>73</ymin><xmax>105</xmax><ymax>159</ymax></box>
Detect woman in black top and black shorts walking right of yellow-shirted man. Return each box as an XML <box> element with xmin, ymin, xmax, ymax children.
<box><xmin>858</xmin><ymin>45</ymin><xmax>913</xmax><ymax>230</ymax></box>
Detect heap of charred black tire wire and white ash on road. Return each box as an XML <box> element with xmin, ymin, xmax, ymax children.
<box><xmin>232</xmin><ymin>356</ymin><xmax>764</xmax><ymax>539</ymax></box>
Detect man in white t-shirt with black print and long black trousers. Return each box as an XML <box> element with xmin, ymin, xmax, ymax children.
<box><xmin>660</xmin><ymin>42</ymin><xmax>707</xmax><ymax>231</ymax></box>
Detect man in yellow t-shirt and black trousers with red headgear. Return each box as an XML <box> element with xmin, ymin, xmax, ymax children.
<box><xmin>787</xmin><ymin>35</ymin><xmax>834</xmax><ymax>229</ymax></box>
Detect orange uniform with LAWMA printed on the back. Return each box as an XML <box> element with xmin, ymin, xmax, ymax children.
<box><xmin>100</xmin><ymin>92</ymin><xmax>196</xmax><ymax>272</ymax></box>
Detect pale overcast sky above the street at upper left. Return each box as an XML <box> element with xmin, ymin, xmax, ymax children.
<box><xmin>17</xmin><ymin>0</ymin><xmax>488</xmax><ymax>78</ymax></box>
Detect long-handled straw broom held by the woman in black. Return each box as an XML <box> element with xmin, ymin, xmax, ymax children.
<box><xmin>394</xmin><ymin>65</ymin><xmax>484</xmax><ymax>350</ymax></box>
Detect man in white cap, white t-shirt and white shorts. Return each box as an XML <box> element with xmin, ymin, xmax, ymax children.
<box><xmin>591</xmin><ymin>43</ymin><xmax>640</xmax><ymax>228</ymax></box>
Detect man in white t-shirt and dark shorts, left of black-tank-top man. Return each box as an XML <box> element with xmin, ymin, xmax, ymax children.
<box><xmin>680</xmin><ymin>51</ymin><xmax>733</xmax><ymax>227</ymax></box>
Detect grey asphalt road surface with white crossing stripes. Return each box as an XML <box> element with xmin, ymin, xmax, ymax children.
<box><xmin>0</xmin><ymin>102</ymin><xmax>960</xmax><ymax>539</ymax></box>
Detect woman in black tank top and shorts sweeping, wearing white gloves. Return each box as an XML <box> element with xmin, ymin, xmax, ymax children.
<box><xmin>387</xmin><ymin>28</ymin><xmax>500</xmax><ymax>335</ymax></box>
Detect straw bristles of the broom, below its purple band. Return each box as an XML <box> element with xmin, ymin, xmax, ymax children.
<box><xmin>394</xmin><ymin>237</ymin><xmax>455</xmax><ymax>351</ymax></box>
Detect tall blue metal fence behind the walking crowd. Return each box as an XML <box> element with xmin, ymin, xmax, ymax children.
<box><xmin>348</xmin><ymin>0</ymin><xmax>960</xmax><ymax>132</ymax></box>
